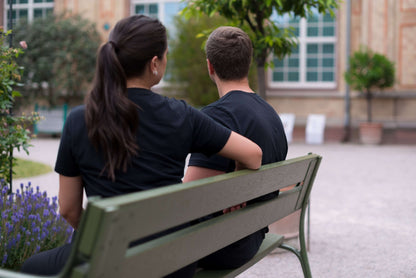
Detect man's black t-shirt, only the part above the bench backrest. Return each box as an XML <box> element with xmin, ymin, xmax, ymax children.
<box><xmin>189</xmin><ymin>91</ymin><xmax>288</xmax><ymax>173</ymax></box>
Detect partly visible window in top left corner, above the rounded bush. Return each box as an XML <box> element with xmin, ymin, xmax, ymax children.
<box><xmin>3</xmin><ymin>0</ymin><xmax>53</xmax><ymax>27</ymax></box>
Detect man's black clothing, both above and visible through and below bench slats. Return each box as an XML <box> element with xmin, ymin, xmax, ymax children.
<box><xmin>189</xmin><ymin>91</ymin><xmax>287</xmax><ymax>269</ymax></box>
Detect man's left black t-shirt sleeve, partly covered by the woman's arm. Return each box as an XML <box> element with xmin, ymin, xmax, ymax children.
<box><xmin>188</xmin><ymin>106</ymin><xmax>238</xmax><ymax>172</ymax></box>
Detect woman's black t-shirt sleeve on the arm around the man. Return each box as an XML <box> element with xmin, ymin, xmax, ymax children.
<box><xmin>190</xmin><ymin>107</ymin><xmax>231</xmax><ymax>156</ymax></box>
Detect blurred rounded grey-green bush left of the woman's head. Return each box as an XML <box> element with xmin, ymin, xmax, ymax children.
<box><xmin>14</xmin><ymin>11</ymin><xmax>100</xmax><ymax>105</ymax></box>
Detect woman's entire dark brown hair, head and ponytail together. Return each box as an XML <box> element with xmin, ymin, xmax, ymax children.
<box><xmin>85</xmin><ymin>15</ymin><xmax>167</xmax><ymax>181</ymax></box>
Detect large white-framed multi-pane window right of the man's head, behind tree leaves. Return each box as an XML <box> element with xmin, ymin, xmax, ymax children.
<box><xmin>271</xmin><ymin>8</ymin><xmax>336</xmax><ymax>88</ymax></box>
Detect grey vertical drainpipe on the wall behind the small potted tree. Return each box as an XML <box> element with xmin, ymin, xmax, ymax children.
<box><xmin>342</xmin><ymin>0</ymin><xmax>351</xmax><ymax>142</ymax></box>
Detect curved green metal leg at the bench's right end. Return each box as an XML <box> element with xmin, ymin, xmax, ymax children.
<box><xmin>279</xmin><ymin>202</ymin><xmax>312</xmax><ymax>278</ymax></box>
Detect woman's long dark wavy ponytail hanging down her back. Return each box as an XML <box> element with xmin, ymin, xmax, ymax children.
<box><xmin>85</xmin><ymin>42</ymin><xmax>139</xmax><ymax>181</ymax></box>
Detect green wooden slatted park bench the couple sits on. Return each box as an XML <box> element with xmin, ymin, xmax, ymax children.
<box><xmin>0</xmin><ymin>154</ymin><xmax>321</xmax><ymax>278</ymax></box>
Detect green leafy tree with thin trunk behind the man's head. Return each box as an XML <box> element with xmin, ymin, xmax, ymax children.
<box><xmin>183</xmin><ymin>0</ymin><xmax>337</xmax><ymax>97</ymax></box>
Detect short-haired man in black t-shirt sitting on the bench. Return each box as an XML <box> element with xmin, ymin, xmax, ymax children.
<box><xmin>184</xmin><ymin>27</ymin><xmax>287</xmax><ymax>269</ymax></box>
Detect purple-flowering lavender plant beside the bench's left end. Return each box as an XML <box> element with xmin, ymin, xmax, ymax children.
<box><xmin>0</xmin><ymin>180</ymin><xmax>73</xmax><ymax>270</ymax></box>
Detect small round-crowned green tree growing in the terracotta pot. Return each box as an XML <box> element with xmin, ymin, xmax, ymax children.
<box><xmin>344</xmin><ymin>48</ymin><xmax>395</xmax><ymax>122</ymax></box>
